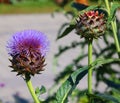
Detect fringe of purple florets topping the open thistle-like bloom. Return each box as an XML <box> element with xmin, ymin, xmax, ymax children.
<box><xmin>7</xmin><ymin>30</ymin><xmax>49</xmax><ymax>56</ymax></box>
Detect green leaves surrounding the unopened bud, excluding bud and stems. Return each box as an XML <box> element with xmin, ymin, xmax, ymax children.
<box><xmin>47</xmin><ymin>0</ymin><xmax>120</xmax><ymax>103</ymax></box>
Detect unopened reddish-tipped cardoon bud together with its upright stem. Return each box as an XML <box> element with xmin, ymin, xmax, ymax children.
<box><xmin>76</xmin><ymin>10</ymin><xmax>107</xmax><ymax>100</ymax></box>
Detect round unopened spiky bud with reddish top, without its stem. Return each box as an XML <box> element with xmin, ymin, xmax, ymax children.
<box><xmin>76</xmin><ymin>11</ymin><xmax>106</xmax><ymax>40</ymax></box>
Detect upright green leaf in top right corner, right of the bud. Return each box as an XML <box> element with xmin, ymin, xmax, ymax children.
<box><xmin>108</xmin><ymin>3</ymin><xmax>120</xmax><ymax>22</ymax></box>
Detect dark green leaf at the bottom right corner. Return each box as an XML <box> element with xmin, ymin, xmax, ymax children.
<box><xmin>89</xmin><ymin>93</ymin><xmax>120</xmax><ymax>103</ymax></box>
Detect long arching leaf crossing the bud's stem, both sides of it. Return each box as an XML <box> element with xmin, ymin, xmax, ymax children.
<box><xmin>53</xmin><ymin>58</ymin><xmax>120</xmax><ymax>103</ymax></box>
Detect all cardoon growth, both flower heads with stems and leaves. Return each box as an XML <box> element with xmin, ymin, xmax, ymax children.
<box><xmin>7</xmin><ymin>0</ymin><xmax>120</xmax><ymax>103</ymax></box>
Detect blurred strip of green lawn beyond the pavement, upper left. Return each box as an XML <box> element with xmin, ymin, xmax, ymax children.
<box><xmin>0</xmin><ymin>0</ymin><xmax>57</xmax><ymax>14</ymax></box>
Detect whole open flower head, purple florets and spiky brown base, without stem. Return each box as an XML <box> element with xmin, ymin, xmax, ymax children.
<box><xmin>7</xmin><ymin>30</ymin><xmax>49</xmax><ymax>75</ymax></box>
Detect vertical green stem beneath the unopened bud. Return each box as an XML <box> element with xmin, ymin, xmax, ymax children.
<box><xmin>88</xmin><ymin>40</ymin><xmax>92</xmax><ymax>103</ymax></box>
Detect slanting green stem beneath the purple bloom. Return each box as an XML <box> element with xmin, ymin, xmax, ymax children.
<box><xmin>26</xmin><ymin>79</ymin><xmax>40</xmax><ymax>103</ymax></box>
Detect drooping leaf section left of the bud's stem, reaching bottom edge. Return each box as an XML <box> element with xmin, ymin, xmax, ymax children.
<box><xmin>56</xmin><ymin>66</ymin><xmax>88</xmax><ymax>103</ymax></box>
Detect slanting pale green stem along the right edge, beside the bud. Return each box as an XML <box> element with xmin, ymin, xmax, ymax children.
<box><xmin>105</xmin><ymin>0</ymin><xmax>120</xmax><ymax>58</ymax></box>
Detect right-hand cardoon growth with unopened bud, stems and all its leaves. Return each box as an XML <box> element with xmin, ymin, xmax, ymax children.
<box><xmin>47</xmin><ymin>0</ymin><xmax>120</xmax><ymax>103</ymax></box>
